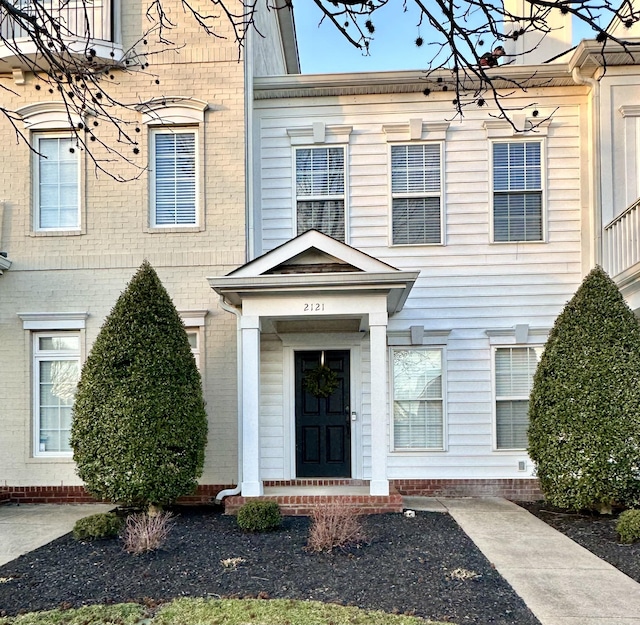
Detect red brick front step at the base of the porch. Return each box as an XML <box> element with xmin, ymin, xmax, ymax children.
<box><xmin>224</xmin><ymin>480</ymin><xmax>402</xmax><ymax>516</ymax></box>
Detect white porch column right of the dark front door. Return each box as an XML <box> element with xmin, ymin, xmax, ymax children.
<box><xmin>369</xmin><ymin>312</ymin><xmax>389</xmax><ymax>495</ymax></box>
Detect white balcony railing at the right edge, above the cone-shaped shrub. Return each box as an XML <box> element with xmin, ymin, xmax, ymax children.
<box><xmin>604</xmin><ymin>199</ymin><xmax>640</xmax><ymax>277</ymax></box>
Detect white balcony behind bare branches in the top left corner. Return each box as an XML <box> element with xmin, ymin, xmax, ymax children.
<box><xmin>0</xmin><ymin>0</ymin><xmax>122</xmax><ymax>70</ymax></box>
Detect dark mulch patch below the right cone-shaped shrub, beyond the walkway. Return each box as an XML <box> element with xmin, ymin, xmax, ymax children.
<box><xmin>518</xmin><ymin>502</ymin><xmax>640</xmax><ymax>583</ymax></box>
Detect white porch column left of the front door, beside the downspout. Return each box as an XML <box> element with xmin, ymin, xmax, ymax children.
<box><xmin>240</xmin><ymin>316</ymin><xmax>263</xmax><ymax>497</ymax></box>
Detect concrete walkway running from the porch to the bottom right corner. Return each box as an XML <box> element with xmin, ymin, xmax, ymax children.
<box><xmin>404</xmin><ymin>497</ymin><xmax>640</xmax><ymax>625</ymax></box>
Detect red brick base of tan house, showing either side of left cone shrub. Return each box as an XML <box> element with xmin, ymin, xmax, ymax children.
<box><xmin>0</xmin><ymin>484</ymin><xmax>231</xmax><ymax>505</ymax></box>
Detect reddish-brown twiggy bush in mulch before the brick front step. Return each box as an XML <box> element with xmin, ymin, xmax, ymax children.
<box><xmin>307</xmin><ymin>502</ymin><xmax>366</xmax><ymax>552</ymax></box>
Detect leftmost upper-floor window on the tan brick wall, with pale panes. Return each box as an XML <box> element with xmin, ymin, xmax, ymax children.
<box><xmin>33</xmin><ymin>134</ymin><xmax>80</xmax><ymax>231</ymax></box>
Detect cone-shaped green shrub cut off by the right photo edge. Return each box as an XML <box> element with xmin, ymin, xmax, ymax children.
<box><xmin>529</xmin><ymin>267</ymin><xmax>640</xmax><ymax>511</ymax></box>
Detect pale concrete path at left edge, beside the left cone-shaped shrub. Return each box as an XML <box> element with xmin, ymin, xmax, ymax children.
<box><xmin>0</xmin><ymin>504</ymin><xmax>114</xmax><ymax>566</ymax></box>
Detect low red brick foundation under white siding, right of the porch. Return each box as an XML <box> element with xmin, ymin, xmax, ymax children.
<box><xmin>391</xmin><ymin>478</ymin><xmax>544</xmax><ymax>501</ymax></box>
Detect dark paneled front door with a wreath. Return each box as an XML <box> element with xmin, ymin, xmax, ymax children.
<box><xmin>295</xmin><ymin>350</ymin><xmax>351</xmax><ymax>477</ymax></box>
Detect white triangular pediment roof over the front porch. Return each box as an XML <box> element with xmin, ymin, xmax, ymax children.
<box><xmin>208</xmin><ymin>230</ymin><xmax>419</xmax><ymax>314</ymax></box>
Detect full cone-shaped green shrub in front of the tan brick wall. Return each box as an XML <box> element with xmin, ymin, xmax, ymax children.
<box><xmin>71</xmin><ymin>261</ymin><xmax>207</xmax><ymax>505</ymax></box>
